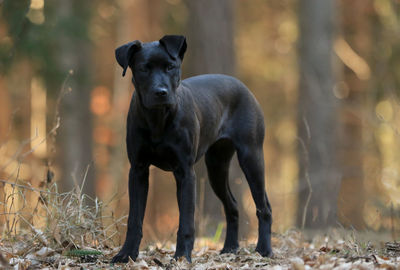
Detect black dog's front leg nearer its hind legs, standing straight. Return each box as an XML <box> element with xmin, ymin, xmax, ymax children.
<box><xmin>174</xmin><ymin>166</ymin><xmax>196</xmax><ymax>262</ymax></box>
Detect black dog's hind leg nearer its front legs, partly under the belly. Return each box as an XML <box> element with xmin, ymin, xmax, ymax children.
<box><xmin>205</xmin><ymin>139</ymin><xmax>239</xmax><ymax>253</ymax></box>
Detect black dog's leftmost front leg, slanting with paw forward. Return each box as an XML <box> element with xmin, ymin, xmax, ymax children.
<box><xmin>111</xmin><ymin>166</ymin><xmax>149</xmax><ymax>263</ymax></box>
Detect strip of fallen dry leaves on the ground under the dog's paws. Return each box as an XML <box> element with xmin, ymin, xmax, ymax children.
<box><xmin>0</xmin><ymin>231</ymin><xmax>400</xmax><ymax>269</ymax></box>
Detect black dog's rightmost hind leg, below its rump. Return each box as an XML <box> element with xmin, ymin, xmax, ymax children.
<box><xmin>237</xmin><ymin>144</ymin><xmax>272</xmax><ymax>256</ymax></box>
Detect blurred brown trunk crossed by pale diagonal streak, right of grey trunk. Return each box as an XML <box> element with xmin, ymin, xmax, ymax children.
<box><xmin>335</xmin><ymin>0</ymin><xmax>376</xmax><ymax>229</ymax></box>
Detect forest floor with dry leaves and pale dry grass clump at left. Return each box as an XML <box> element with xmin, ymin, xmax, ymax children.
<box><xmin>0</xmin><ymin>178</ymin><xmax>400</xmax><ymax>270</ymax></box>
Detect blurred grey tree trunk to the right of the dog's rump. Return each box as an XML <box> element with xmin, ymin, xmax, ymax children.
<box><xmin>297</xmin><ymin>0</ymin><xmax>340</xmax><ymax>228</ymax></box>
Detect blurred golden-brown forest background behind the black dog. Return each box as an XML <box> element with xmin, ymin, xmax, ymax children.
<box><xmin>0</xmin><ymin>0</ymin><xmax>400</xmax><ymax>247</ymax></box>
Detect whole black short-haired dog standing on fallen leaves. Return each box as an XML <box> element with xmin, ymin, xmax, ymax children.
<box><xmin>112</xmin><ymin>36</ymin><xmax>272</xmax><ymax>263</ymax></box>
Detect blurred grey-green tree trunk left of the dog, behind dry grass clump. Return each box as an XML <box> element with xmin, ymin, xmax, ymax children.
<box><xmin>57</xmin><ymin>0</ymin><xmax>95</xmax><ymax>198</ymax></box>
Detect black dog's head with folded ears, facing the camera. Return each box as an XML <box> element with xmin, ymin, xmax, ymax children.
<box><xmin>115</xmin><ymin>35</ymin><xmax>186</xmax><ymax>109</ymax></box>
